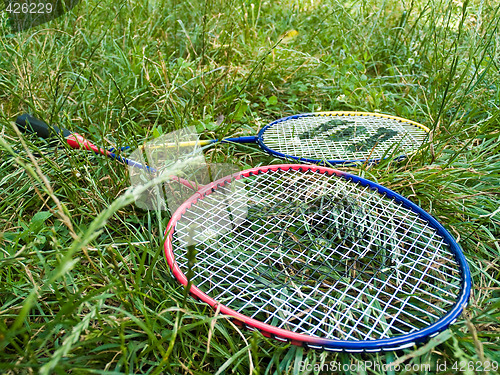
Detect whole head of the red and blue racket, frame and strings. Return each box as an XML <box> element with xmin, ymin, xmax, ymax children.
<box><xmin>164</xmin><ymin>164</ymin><xmax>471</xmax><ymax>352</ymax></box>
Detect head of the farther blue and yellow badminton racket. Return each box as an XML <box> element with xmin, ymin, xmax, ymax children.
<box><xmin>257</xmin><ymin>112</ymin><xmax>429</xmax><ymax>165</ymax></box>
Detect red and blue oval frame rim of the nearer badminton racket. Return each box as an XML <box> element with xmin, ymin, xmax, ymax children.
<box><xmin>164</xmin><ymin>164</ymin><xmax>472</xmax><ymax>353</ymax></box>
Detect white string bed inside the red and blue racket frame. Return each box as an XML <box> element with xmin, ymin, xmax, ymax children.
<box><xmin>173</xmin><ymin>170</ymin><xmax>461</xmax><ymax>340</ymax></box>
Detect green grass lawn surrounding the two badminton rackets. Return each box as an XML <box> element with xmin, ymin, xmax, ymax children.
<box><xmin>0</xmin><ymin>0</ymin><xmax>500</xmax><ymax>374</ymax></box>
